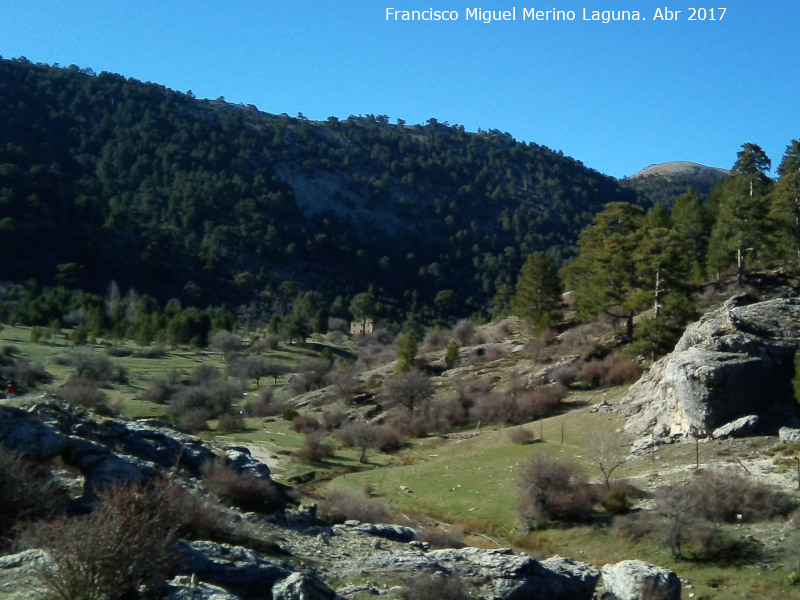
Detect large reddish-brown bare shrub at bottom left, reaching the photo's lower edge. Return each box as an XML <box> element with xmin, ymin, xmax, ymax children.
<box><xmin>21</xmin><ymin>485</ymin><xmax>175</xmax><ymax>600</ymax></box>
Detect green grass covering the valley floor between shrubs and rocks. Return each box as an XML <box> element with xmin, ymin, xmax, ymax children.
<box><xmin>0</xmin><ymin>326</ymin><xmax>800</xmax><ymax>600</ymax></box>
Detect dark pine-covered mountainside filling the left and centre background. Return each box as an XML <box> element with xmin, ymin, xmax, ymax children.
<box><xmin>0</xmin><ymin>59</ymin><xmax>635</xmax><ymax>322</ymax></box>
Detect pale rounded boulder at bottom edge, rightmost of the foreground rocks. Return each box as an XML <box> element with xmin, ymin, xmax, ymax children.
<box><xmin>603</xmin><ymin>560</ymin><xmax>681</xmax><ymax>600</ymax></box>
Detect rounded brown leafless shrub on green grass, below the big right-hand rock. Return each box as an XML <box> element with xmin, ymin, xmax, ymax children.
<box><xmin>519</xmin><ymin>454</ymin><xmax>595</xmax><ymax>528</ymax></box>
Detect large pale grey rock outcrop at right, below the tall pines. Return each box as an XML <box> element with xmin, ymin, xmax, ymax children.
<box><xmin>620</xmin><ymin>296</ymin><xmax>800</xmax><ymax>437</ymax></box>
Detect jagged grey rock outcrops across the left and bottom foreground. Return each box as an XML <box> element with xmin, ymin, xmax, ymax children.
<box><xmin>0</xmin><ymin>399</ymin><xmax>681</xmax><ymax>600</ymax></box>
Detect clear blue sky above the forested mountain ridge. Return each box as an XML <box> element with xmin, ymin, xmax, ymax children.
<box><xmin>0</xmin><ymin>0</ymin><xmax>800</xmax><ymax>177</ymax></box>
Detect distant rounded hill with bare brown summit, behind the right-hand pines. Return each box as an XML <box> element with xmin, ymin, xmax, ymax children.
<box><xmin>620</xmin><ymin>161</ymin><xmax>729</xmax><ymax>208</ymax></box>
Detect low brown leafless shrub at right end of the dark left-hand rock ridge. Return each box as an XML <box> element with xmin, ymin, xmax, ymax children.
<box><xmin>202</xmin><ymin>460</ymin><xmax>284</xmax><ymax>513</ymax></box>
